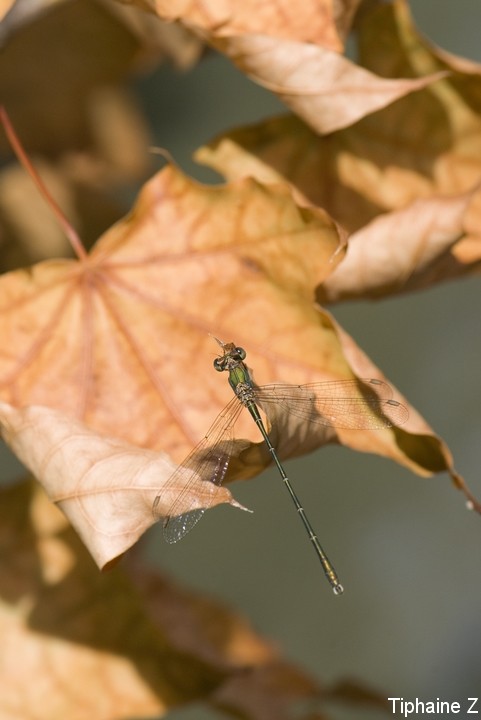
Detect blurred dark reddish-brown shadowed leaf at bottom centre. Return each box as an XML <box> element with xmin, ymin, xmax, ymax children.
<box><xmin>131</xmin><ymin>569</ymin><xmax>332</xmax><ymax>720</ymax></box>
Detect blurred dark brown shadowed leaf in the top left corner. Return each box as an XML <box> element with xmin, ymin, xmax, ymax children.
<box><xmin>0</xmin><ymin>0</ymin><xmax>146</xmax><ymax>158</ymax></box>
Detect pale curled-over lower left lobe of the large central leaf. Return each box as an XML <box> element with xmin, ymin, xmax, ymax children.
<box><xmin>0</xmin><ymin>403</ymin><xmax>242</xmax><ymax>568</ymax></box>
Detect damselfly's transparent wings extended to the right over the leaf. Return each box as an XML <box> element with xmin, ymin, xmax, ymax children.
<box><xmin>254</xmin><ymin>378</ymin><xmax>409</xmax><ymax>430</ymax></box>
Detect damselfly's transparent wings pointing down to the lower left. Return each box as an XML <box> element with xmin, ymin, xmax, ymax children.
<box><xmin>152</xmin><ymin>397</ymin><xmax>243</xmax><ymax>543</ymax></box>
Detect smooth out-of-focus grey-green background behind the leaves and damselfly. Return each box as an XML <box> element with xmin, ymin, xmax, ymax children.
<box><xmin>2</xmin><ymin>0</ymin><xmax>481</xmax><ymax>720</ymax></box>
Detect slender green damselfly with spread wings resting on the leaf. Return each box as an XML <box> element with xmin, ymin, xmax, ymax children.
<box><xmin>153</xmin><ymin>338</ymin><xmax>408</xmax><ymax>595</ymax></box>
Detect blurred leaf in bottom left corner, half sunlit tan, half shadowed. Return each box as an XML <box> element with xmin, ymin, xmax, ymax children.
<box><xmin>0</xmin><ymin>484</ymin><xmax>212</xmax><ymax>720</ymax></box>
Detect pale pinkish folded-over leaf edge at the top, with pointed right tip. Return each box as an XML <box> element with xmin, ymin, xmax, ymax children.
<box><xmin>215</xmin><ymin>35</ymin><xmax>444</xmax><ymax>134</ymax></box>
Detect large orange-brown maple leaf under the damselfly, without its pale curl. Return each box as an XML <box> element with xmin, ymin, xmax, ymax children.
<box><xmin>0</xmin><ymin>162</ymin><xmax>468</xmax><ymax>522</ymax></box>
